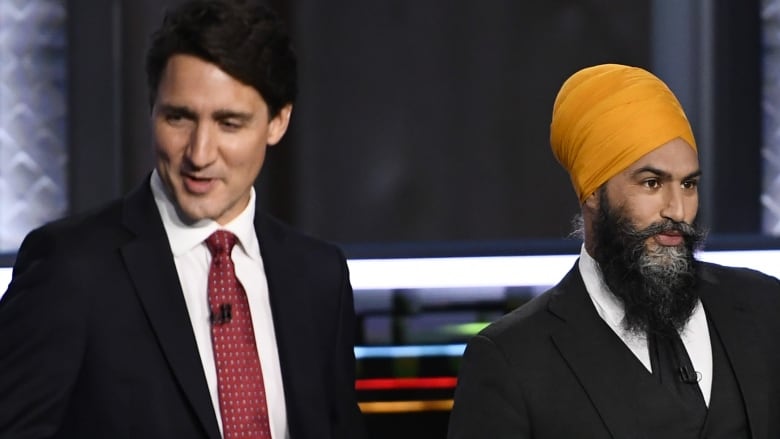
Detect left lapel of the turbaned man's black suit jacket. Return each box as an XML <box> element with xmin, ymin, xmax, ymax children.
<box><xmin>548</xmin><ymin>264</ymin><xmax>645</xmax><ymax>439</ymax></box>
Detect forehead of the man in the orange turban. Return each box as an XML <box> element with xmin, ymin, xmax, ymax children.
<box><xmin>619</xmin><ymin>138</ymin><xmax>699</xmax><ymax>177</ymax></box>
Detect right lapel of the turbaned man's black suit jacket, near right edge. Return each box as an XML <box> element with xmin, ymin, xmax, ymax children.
<box><xmin>700</xmin><ymin>268</ymin><xmax>770</xmax><ymax>438</ymax></box>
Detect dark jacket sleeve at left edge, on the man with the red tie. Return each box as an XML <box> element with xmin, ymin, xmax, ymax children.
<box><xmin>0</xmin><ymin>231</ymin><xmax>86</xmax><ymax>439</ymax></box>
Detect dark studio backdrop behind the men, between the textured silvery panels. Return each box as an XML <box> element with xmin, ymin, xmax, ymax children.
<box><xmin>59</xmin><ymin>0</ymin><xmax>761</xmax><ymax>439</ymax></box>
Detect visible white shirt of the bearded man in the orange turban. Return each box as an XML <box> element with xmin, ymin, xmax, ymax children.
<box><xmin>579</xmin><ymin>245</ymin><xmax>712</xmax><ymax>406</ymax></box>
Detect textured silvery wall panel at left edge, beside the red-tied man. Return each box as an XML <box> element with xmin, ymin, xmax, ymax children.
<box><xmin>0</xmin><ymin>0</ymin><xmax>68</xmax><ymax>252</ymax></box>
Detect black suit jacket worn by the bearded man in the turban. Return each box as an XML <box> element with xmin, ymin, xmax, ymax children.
<box><xmin>448</xmin><ymin>263</ymin><xmax>780</xmax><ymax>439</ymax></box>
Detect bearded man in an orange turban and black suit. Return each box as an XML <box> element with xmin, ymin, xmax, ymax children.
<box><xmin>449</xmin><ymin>64</ymin><xmax>780</xmax><ymax>439</ymax></box>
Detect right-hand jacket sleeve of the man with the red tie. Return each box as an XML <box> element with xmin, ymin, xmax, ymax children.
<box><xmin>332</xmin><ymin>252</ymin><xmax>366</xmax><ymax>439</ymax></box>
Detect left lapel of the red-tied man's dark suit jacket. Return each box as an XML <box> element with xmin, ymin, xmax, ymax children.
<box><xmin>121</xmin><ymin>182</ymin><xmax>220</xmax><ymax>438</ymax></box>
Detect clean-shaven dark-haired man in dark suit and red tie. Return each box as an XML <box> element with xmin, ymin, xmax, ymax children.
<box><xmin>0</xmin><ymin>0</ymin><xmax>363</xmax><ymax>439</ymax></box>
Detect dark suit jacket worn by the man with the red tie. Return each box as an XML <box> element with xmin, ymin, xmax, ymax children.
<box><xmin>0</xmin><ymin>183</ymin><xmax>363</xmax><ymax>439</ymax></box>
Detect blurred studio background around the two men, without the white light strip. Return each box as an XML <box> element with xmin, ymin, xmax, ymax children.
<box><xmin>0</xmin><ymin>0</ymin><xmax>780</xmax><ymax>438</ymax></box>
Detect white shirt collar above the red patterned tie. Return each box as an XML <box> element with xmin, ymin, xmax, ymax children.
<box><xmin>150</xmin><ymin>169</ymin><xmax>259</xmax><ymax>257</ymax></box>
